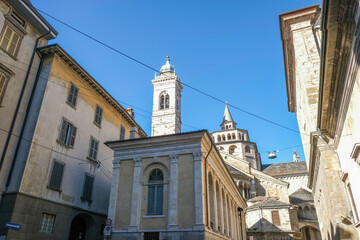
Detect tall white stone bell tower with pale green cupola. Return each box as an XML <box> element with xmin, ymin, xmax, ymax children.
<box><xmin>151</xmin><ymin>56</ymin><xmax>183</xmax><ymax>136</ymax></box>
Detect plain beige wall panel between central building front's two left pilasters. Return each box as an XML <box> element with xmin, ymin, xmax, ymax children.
<box><xmin>114</xmin><ymin>160</ymin><xmax>134</xmax><ymax>230</ymax></box>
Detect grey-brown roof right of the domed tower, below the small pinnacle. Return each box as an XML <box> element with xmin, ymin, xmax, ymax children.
<box><xmin>262</xmin><ymin>161</ymin><xmax>308</xmax><ymax>177</ymax></box>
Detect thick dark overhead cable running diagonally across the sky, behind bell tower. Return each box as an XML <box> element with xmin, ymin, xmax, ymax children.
<box><xmin>36</xmin><ymin>8</ymin><xmax>309</xmax><ymax>136</ymax></box>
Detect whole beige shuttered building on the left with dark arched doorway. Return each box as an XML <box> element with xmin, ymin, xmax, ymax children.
<box><xmin>0</xmin><ymin>44</ymin><xmax>146</xmax><ymax>239</ymax></box>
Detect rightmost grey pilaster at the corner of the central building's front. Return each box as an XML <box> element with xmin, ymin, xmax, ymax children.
<box><xmin>193</xmin><ymin>152</ymin><xmax>206</xmax><ymax>230</ymax></box>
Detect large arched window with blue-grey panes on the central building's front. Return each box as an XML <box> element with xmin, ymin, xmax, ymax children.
<box><xmin>147</xmin><ymin>169</ymin><xmax>164</xmax><ymax>215</ymax></box>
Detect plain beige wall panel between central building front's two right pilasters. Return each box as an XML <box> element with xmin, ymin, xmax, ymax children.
<box><xmin>178</xmin><ymin>154</ymin><xmax>195</xmax><ymax>228</ymax></box>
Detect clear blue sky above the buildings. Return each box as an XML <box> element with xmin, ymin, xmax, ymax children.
<box><xmin>32</xmin><ymin>0</ymin><xmax>320</xmax><ymax>163</ymax></box>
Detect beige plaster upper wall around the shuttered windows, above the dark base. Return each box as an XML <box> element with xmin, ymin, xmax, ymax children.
<box><xmin>20</xmin><ymin>56</ymin><xmax>134</xmax><ymax>214</ymax></box>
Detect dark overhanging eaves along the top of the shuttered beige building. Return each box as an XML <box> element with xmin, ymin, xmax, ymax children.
<box><xmin>38</xmin><ymin>44</ymin><xmax>147</xmax><ymax>137</ymax></box>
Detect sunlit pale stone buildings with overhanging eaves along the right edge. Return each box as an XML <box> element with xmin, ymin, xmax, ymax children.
<box><xmin>280</xmin><ymin>0</ymin><xmax>360</xmax><ymax>239</ymax></box>
